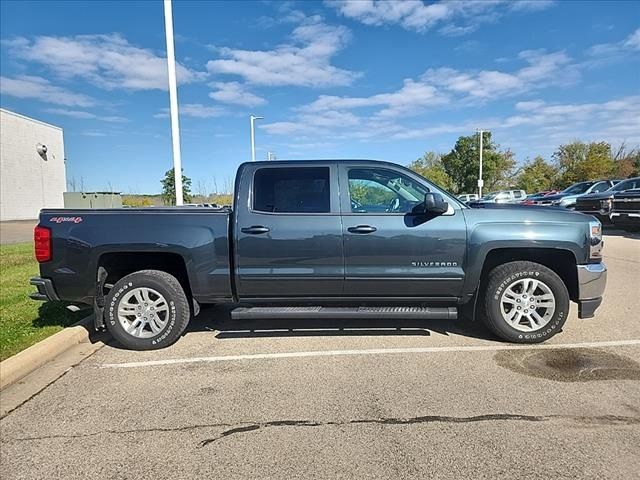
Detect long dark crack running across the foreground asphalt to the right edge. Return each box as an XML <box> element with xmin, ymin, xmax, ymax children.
<box><xmin>198</xmin><ymin>413</ymin><xmax>640</xmax><ymax>448</ymax></box>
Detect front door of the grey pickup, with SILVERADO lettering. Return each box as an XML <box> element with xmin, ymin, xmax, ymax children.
<box><xmin>339</xmin><ymin>163</ymin><xmax>466</xmax><ymax>300</ymax></box>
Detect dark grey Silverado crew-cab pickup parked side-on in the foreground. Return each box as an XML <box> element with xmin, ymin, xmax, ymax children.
<box><xmin>31</xmin><ymin>160</ymin><xmax>606</xmax><ymax>350</ymax></box>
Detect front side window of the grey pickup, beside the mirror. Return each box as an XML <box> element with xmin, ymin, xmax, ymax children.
<box><xmin>349</xmin><ymin>168</ymin><xmax>429</xmax><ymax>213</ymax></box>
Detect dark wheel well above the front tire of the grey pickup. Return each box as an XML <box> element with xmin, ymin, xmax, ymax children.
<box><xmin>480</xmin><ymin>248</ymin><xmax>578</xmax><ymax>302</ymax></box>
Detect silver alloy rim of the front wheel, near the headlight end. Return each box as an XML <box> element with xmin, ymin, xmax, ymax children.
<box><xmin>500</xmin><ymin>278</ymin><xmax>556</xmax><ymax>332</ymax></box>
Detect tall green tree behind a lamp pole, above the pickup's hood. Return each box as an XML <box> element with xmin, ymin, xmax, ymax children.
<box><xmin>442</xmin><ymin>132</ymin><xmax>515</xmax><ymax>193</ymax></box>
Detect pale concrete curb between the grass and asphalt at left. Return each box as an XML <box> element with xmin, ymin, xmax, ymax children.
<box><xmin>0</xmin><ymin>314</ymin><xmax>93</xmax><ymax>390</ymax></box>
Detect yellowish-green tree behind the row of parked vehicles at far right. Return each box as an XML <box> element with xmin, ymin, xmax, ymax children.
<box><xmin>553</xmin><ymin>141</ymin><xmax>615</xmax><ymax>187</ymax></box>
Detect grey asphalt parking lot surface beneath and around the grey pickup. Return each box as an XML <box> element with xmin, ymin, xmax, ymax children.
<box><xmin>0</xmin><ymin>232</ymin><xmax>640</xmax><ymax>479</ymax></box>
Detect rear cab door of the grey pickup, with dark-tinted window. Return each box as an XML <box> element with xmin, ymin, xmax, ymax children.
<box><xmin>234</xmin><ymin>162</ymin><xmax>344</xmax><ymax>299</ymax></box>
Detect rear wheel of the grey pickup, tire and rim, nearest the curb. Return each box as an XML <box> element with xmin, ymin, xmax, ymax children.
<box><xmin>105</xmin><ymin>270</ymin><xmax>191</xmax><ymax>350</ymax></box>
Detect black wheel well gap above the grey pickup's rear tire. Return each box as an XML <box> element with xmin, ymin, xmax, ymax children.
<box><xmin>98</xmin><ymin>252</ymin><xmax>191</xmax><ymax>298</ymax></box>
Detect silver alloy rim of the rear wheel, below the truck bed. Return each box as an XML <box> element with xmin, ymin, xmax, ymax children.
<box><xmin>118</xmin><ymin>287</ymin><xmax>169</xmax><ymax>338</ymax></box>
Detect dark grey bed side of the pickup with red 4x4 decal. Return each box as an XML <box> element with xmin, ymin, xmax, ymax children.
<box><xmin>40</xmin><ymin>207</ymin><xmax>232</xmax><ymax>304</ymax></box>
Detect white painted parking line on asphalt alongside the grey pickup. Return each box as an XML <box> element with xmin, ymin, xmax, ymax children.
<box><xmin>100</xmin><ymin>340</ymin><xmax>640</xmax><ymax>368</ymax></box>
